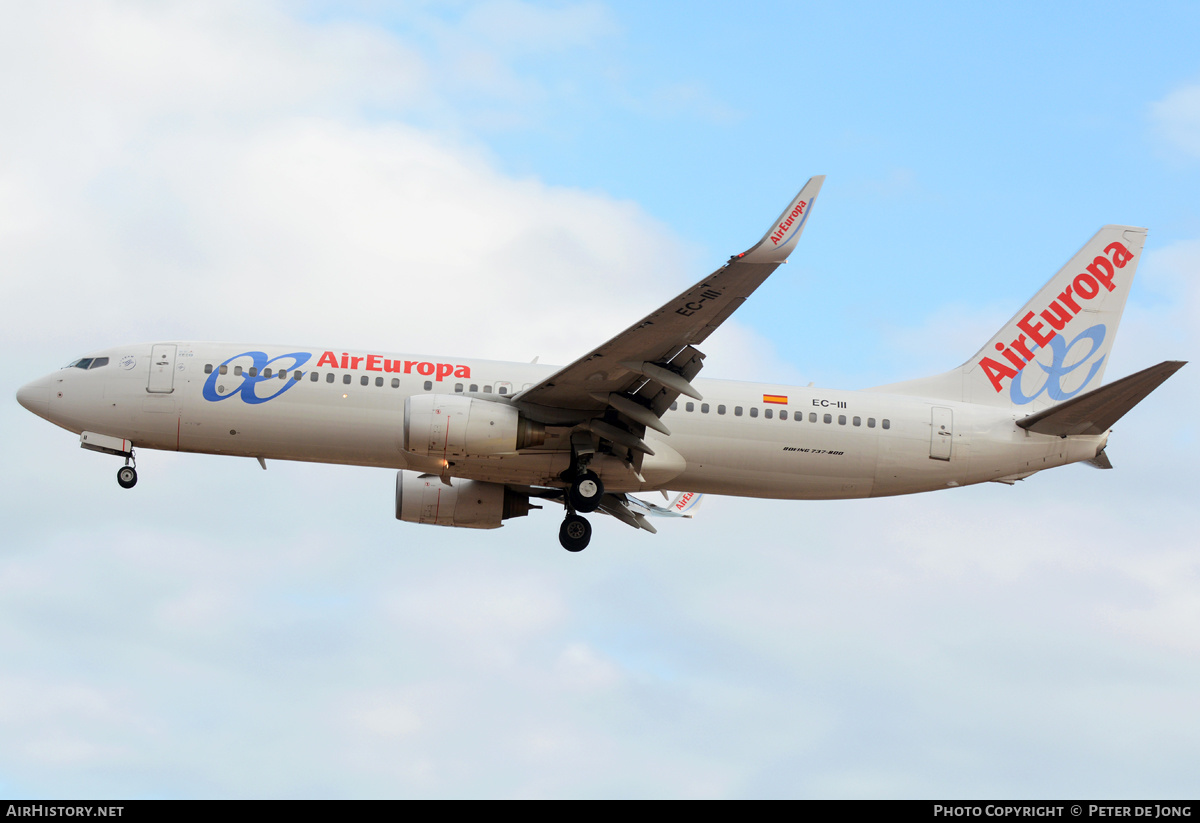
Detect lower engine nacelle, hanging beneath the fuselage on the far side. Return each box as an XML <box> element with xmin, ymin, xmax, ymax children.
<box><xmin>396</xmin><ymin>471</ymin><xmax>529</xmax><ymax>529</ymax></box>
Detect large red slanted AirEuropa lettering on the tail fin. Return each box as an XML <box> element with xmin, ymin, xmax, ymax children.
<box><xmin>979</xmin><ymin>242</ymin><xmax>1133</xmax><ymax>392</ymax></box>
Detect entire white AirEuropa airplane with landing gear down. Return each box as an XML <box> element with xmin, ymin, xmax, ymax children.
<box><xmin>17</xmin><ymin>175</ymin><xmax>1184</xmax><ymax>552</ymax></box>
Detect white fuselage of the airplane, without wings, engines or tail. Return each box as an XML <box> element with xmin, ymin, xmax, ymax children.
<box><xmin>19</xmin><ymin>342</ymin><xmax>1106</xmax><ymax>499</ymax></box>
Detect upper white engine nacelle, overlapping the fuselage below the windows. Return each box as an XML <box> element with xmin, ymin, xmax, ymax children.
<box><xmin>401</xmin><ymin>395</ymin><xmax>546</xmax><ymax>457</ymax></box>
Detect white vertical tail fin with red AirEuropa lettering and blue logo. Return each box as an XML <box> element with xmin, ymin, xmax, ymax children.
<box><xmin>872</xmin><ymin>226</ymin><xmax>1146</xmax><ymax>412</ymax></box>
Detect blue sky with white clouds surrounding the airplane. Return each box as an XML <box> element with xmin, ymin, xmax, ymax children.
<box><xmin>0</xmin><ymin>2</ymin><xmax>1200</xmax><ymax>798</ymax></box>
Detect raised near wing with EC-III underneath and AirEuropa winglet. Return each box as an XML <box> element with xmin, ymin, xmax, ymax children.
<box><xmin>512</xmin><ymin>175</ymin><xmax>824</xmax><ymax>453</ymax></box>
